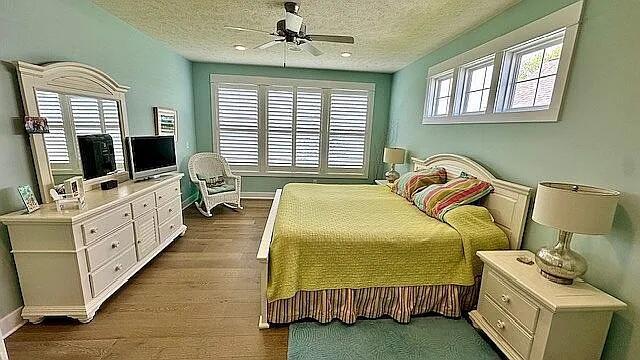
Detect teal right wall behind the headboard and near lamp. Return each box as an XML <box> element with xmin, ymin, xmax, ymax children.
<box><xmin>388</xmin><ymin>0</ymin><xmax>640</xmax><ymax>359</ymax></box>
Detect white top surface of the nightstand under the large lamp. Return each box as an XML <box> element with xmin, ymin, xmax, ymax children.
<box><xmin>477</xmin><ymin>250</ymin><xmax>626</xmax><ymax>311</ymax></box>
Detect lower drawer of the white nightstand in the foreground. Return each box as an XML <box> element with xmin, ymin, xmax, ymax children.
<box><xmin>478</xmin><ymin>295</ymin><xmax>533</xmax><ymax>359</ymax></box>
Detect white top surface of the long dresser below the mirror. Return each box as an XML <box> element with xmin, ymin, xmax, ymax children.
<box><xmin>0</xmin><ymin>173</ymin><xmax>184</xmax><ymax>224</ymax></box>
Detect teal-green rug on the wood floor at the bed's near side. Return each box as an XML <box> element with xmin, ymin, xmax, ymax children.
<box><xmin>289</xmin><ymin>316</ymin><xmax>500</xmax><ymax>360</ymax></box>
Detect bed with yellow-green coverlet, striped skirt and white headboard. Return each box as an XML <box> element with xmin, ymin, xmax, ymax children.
<box><xmin>257</xmin><ymin>154</ymin><xmax>531</xmax><ymax>329</ymax></box>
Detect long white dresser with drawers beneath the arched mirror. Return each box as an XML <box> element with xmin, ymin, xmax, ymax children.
<box><xmin>0</xmin><ymin>174</ymin><xmax>187</xmax><ymax>323</ymax></box>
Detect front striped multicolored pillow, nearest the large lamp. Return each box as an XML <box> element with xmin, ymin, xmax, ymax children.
<box><xmin>413</xmin><ymin>178</ymin><xmax>493</xmax><ymax>221</ymax></box>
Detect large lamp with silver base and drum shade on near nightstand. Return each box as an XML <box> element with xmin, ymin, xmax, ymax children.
<box><xmin>532</xmin><ymin>182</ymin><xmax>620</xmax><ymax>285</ymax></box>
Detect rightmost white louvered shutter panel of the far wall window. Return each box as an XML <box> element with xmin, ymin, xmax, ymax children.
<box><xmin>327</xmin><ymin>90</ymin><xmax>369</xmax><ymax>169</ymax></box>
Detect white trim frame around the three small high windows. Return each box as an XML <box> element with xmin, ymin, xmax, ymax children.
<box><xmin>422</xmin><ymin>1</ymin><xmax>583</xmax><ymax>125</ymax></box>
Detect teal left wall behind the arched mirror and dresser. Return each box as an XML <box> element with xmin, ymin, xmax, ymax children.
<box><xmin>0</xmin><ymin>0</ymin><xmax>196</xmax><ymax>317</ymax></box>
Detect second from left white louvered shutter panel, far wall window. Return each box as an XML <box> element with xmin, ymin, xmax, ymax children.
<box><xmin>267</xmin><ymin>86</ymin><xmax>293</xmax><ymax>167</ymax></box>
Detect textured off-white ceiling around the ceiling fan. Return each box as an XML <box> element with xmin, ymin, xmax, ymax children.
<box><xmin>94</xmin><ymin>0</ymin><xmax>519</xmax><ymax>72</ymax></box>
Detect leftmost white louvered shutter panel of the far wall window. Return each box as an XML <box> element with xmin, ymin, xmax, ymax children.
<box><xmin>216</xmin><ymin>84</ymin><xmax>258</xmax><ymax>169</ymax></box>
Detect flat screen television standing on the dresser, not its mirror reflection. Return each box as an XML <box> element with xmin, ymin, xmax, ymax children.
<box><xmin>126</xmin><ymin>135</ymin><xmax>178</xmax><ymax>180</ymax></box>
